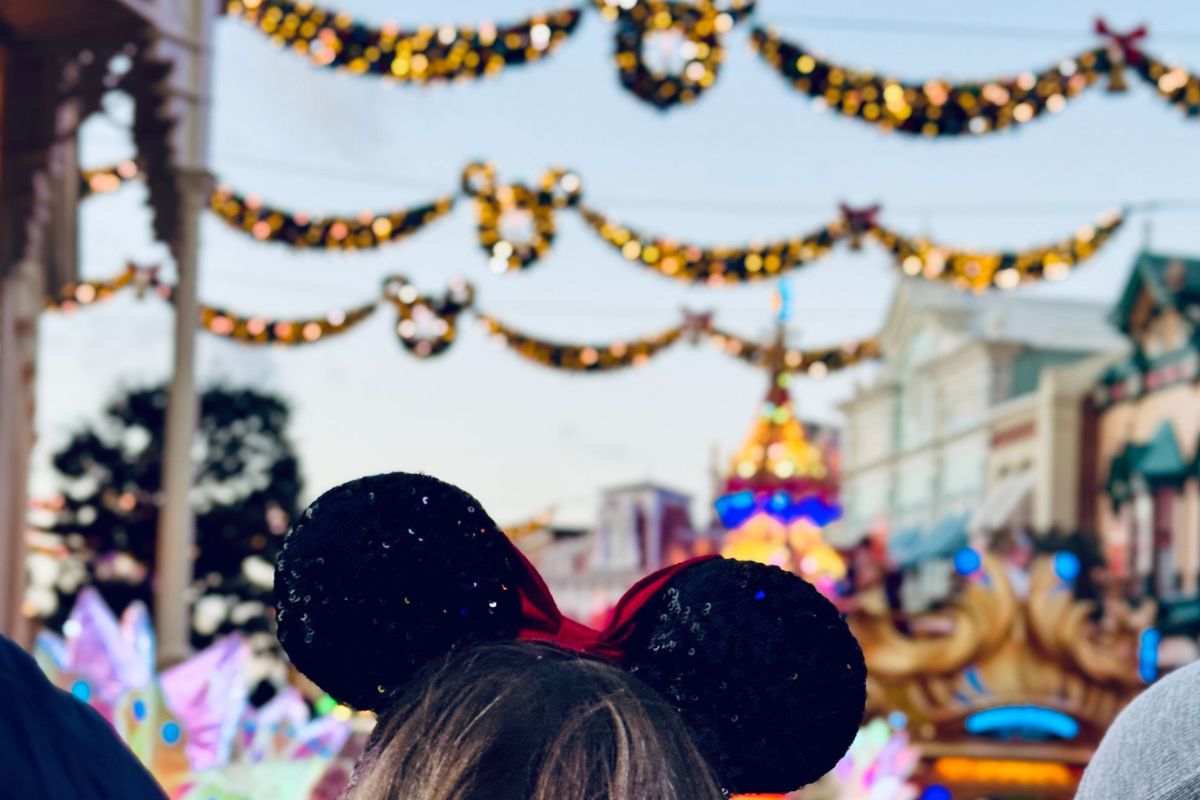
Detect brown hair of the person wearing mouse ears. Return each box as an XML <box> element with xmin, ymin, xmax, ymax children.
<box><xmin>347</xmin><ymin>643</ymin><xmax>722</xmax><ymax>800</ymax></box>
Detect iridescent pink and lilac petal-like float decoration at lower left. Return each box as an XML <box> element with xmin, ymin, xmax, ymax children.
<box><xmin>35</xmin><ymin>588</ymin><xmax>355</xmax><ymax>800</ymax></box>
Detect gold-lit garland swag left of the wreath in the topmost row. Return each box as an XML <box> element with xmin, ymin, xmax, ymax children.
<box><xmin>224</xmin><ymin>0</ymin><xmax>581</xmax><ymax>83</ymax></box>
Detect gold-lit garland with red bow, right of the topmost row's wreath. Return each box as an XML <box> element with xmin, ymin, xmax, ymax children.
<box><xmin>750</xmin><ymin>19</ymin><xmax>1200</xmax><ymax>137</ymax></box>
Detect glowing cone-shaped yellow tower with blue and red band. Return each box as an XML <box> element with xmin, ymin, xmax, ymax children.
<box><xmin>716</xmin><ymin>329</ymin><xmax>846</xmax><ymax>594</ymax></box>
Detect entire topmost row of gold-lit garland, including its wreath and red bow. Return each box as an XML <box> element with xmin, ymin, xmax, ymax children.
<box><xmin>226</xmin><ymin>0</ymin><xmax>1200</xmax><ymax>125</ymax></box>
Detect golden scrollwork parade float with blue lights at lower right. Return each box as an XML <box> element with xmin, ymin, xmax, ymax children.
<box><xmin>839</xmin><ymin>548</ymin><xmax>1158</xmax><ymax>800</ymax></box>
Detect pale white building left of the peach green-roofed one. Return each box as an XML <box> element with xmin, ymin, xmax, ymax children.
<box><xmin>830</xmin><ymin>279</ymin><xmax>1123</xmax><ymax>607</ymax></box>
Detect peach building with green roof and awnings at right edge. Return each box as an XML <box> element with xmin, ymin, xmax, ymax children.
<box><xmin>1087</xmin><ymin>252</ymin><xmax>1200</xmax><ymax>661</ymax></box>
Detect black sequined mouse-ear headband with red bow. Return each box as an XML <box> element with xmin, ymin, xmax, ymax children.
<box><xmin>275</xmin><ymin>473</ymin><xmax>866</xmax><ymax>793</ymax></box>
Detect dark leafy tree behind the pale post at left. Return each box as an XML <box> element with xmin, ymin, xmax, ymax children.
<box><xmin>48</xmin><ymin>386</ymin><xmax>301</xmax><ymax>646</ymax></box>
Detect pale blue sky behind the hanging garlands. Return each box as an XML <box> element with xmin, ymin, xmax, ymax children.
<box><xmin>35</xmin><ymin>0</ymin><xmax>1200</xmax><ymax>522</ymax></box>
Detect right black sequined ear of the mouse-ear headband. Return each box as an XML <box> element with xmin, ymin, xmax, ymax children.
<box><xmin>623</xmin><ymin>559</ymin><xmax>866</xmax><ymax>794</ymax></box>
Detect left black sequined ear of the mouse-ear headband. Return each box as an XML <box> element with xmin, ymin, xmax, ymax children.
<box><xmin>275</xmin><ymin>473</ymin><xmax>528</xmax><ymax>710</ymax></box>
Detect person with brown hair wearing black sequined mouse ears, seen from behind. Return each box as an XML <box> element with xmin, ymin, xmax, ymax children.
<box><xmin>275</xmin><ymin>473</ymin><xmax>866</xmax><ymax>800</ymax></box>
